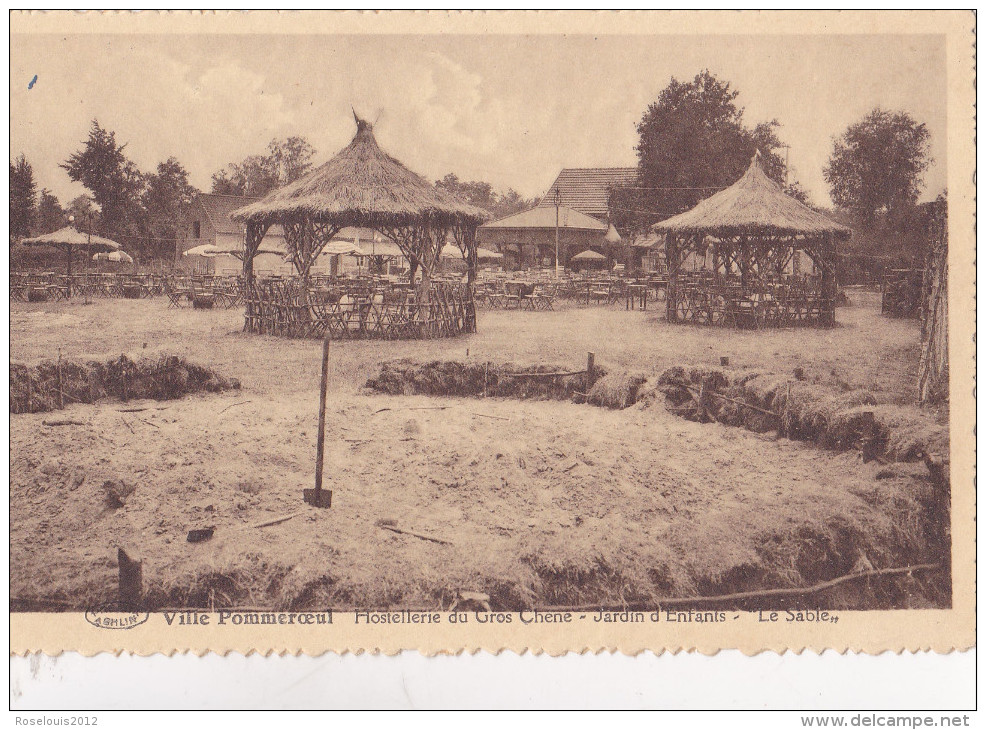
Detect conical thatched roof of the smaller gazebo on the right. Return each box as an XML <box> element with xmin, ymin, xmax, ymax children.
<box><xmin>652</xmin><ymin>152</ymin><xmax>851</xmax><ymax>238</ymax></box>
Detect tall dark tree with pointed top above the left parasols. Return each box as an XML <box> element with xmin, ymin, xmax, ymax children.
<box><xmin>61</xmin><ymin>119</ymin><xmax>146</xmax><ymax>238</ymax></box>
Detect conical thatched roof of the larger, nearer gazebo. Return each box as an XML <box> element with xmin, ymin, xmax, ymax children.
<box><xmin>233</xmin><ymin>117</ymin><xmax>490</xmax><ymax>227</ymax></box>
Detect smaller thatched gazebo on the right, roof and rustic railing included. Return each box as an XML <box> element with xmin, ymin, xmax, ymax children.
<box><xmin>653</xmin><ymin>152</ymin><xmax>851</xmax><ymax>327</ymax></box>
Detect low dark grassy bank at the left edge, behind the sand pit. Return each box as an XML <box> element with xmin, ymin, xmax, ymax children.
<box><xmin>10</xmin><ymin>355</ymin><xmax>240</xmax><ymax>413</ymax></box>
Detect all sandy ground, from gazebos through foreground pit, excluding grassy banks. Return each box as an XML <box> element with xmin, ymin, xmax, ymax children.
<box><xmin>11</xmin><ymin>292</ymin><xmax>925</xmax><ymax>608</ymax></box>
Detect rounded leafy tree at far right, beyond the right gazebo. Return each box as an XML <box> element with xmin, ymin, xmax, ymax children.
<box><xmin>823</xmin><ymin>108</ymin><xmax>932</xmax><ymax>226</ymax></box>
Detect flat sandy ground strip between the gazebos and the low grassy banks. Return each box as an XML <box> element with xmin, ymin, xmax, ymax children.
<box><xmin>10</xmin><ymin>291</ymin><xmax>920</xmax><ymax>402</ymax></box>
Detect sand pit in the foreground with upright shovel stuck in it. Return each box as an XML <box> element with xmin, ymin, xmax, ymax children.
<box><xmin>11</xmin><ymin>386</ymin><xmax>948</xmax><ymax>609</ymax></box>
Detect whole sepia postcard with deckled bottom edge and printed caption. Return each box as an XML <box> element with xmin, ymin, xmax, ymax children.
<box><xmin>8</xmin><ymin>11</ymin><xmax>976</xmax><ymax>655</ymax></box>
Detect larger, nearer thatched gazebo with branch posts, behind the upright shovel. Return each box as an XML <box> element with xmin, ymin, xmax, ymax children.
<box><xmin>233</xmin><ymin>114</ymin><xmax>489</xmax><ymax>336</ymax></box>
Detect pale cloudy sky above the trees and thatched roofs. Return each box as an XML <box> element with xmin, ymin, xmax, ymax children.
<box><xmin>10</xmin><ymin>35</ymin><xmax>947</xmax><ymax>206</ymax></box>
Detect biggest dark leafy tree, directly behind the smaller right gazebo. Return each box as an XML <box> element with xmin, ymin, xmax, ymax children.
<box><xmin>628</xmin><ymin>70</ymin><xmax>785</xmax><ymax>232</ymax></box>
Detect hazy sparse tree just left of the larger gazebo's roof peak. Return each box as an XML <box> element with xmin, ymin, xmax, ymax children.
<box><xmin>212</xmin><ymin>137</ymin><xmax>315</xmax><ymax>197</ymax></box>
